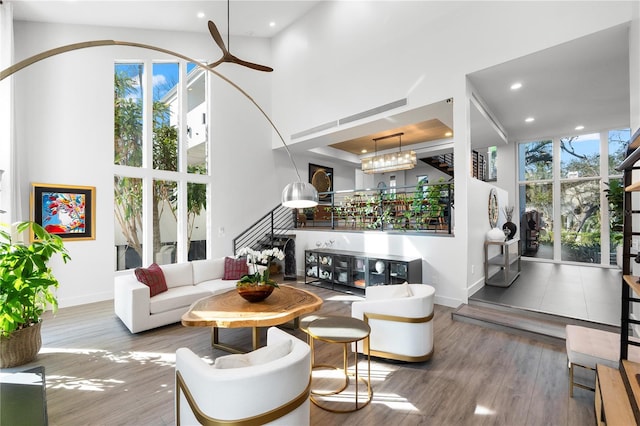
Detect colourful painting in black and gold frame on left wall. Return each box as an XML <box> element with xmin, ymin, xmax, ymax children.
<box><xmin>30</xmin><ymin>183</ymin><xmax>96</xmax><ymax>241</ymax></box>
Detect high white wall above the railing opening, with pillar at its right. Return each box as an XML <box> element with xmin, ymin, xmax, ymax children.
<box><xmin>273</xmin><ymin>1</ymin><xmax>631</xmax><ymax>308</ymax></box>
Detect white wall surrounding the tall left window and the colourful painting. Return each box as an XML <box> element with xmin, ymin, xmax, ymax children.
<box><xmin>14</xmin><ymin>22</ymin><xmax>282</xmax><ymax>306</ymax></box>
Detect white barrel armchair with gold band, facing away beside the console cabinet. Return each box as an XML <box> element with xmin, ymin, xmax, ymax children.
<box><xmin>351</xmin><ymin>283</ymin><xmax>435</xmax><ymax>362</ymax></box>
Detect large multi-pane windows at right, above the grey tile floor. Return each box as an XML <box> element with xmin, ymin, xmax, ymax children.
<box><xmin>518</xmin><ymin>129</ymin><xmax>631</xmax><ymax>264</ymax></box>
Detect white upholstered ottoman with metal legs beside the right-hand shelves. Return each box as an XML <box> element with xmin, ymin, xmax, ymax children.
<box><xmin>566</xmin><ymin>325</ymin><xmax>640</xmax><ymax>397</ymax></box>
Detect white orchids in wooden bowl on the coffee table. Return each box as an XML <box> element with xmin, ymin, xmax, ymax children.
<box><xmin>236</xmin><ymin>247</ymin><xmax>284</xmax><ymax>303</ymax></box>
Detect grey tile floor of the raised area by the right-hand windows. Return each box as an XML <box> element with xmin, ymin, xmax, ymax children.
<box><xmin>470</xmin><ymin>260</ymin><xmax>622</xmax><ymax>326</ymax></box>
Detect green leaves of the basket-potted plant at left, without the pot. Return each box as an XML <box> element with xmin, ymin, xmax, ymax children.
<box><xmin>0</xmin><ymin>222</ymin><xmax>71</xmax><ymax>337</ymax></box>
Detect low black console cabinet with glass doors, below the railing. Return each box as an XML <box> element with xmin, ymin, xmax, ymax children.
<box><xmin>304</xmin><ymin>249</ymin><xmax>422</xmax><ymax>292</ymax></box>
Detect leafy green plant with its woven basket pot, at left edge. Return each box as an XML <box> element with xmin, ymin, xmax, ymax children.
<box><xmin>0</xmin><ymin>222</ymin><xmax>70</xmax><ymax>368</ymax></box>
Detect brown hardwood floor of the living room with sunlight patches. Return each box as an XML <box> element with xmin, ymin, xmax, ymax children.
<box><xmin>3</xmin><ymin>284</ymin><xmax>595</xmax><ymax>426</ymax></box>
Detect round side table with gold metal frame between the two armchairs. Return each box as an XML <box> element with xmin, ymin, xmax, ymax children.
<box><xmin>303</xmin><ymin>316</ymin><xmax>373</xmax><ymax>413</ymax></box>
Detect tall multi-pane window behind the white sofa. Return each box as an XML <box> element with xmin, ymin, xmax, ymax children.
<box><xmin>114</xmin><ymin>61</ymin><xmax>209</xmax><ymax>270</ymax></box>
